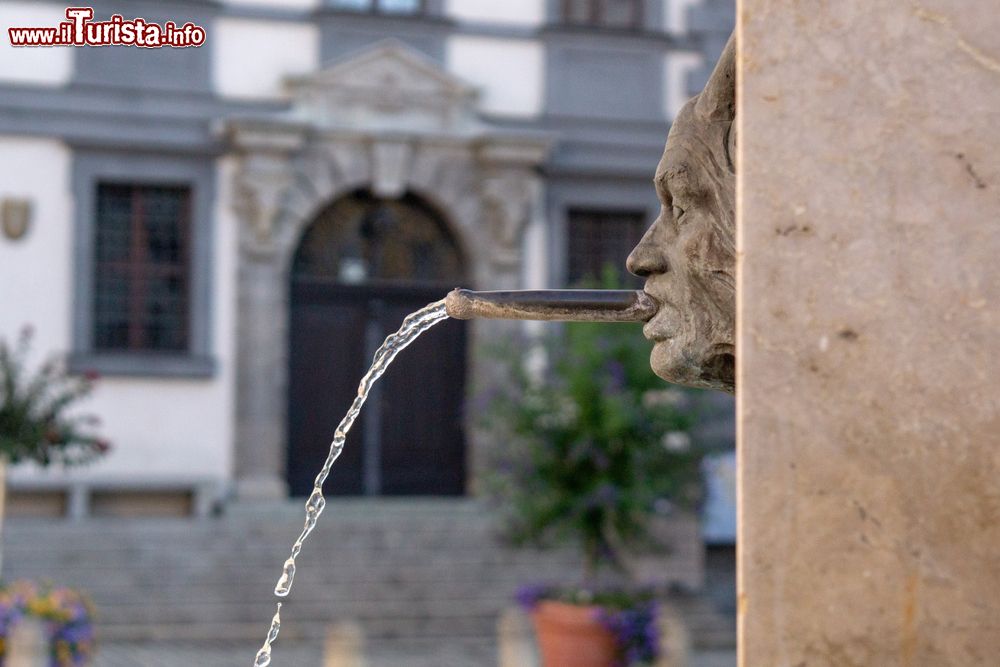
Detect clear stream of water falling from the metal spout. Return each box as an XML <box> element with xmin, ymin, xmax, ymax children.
<box><xmin>254</xmin><ymin>299</ymin><xmax>448</xmax><ymax>667</ymax></box>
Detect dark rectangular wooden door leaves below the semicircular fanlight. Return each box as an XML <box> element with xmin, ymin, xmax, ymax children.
<box><xmin>287</xmin><ymin>278</ymin><xmax>466</xmax><ymax>496</ymax></box>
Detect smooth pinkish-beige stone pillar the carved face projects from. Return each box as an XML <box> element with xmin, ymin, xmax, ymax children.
<box><xmin>737</xmin><ymin>0</ymin><xmax>1000</xmax><ymax>667</ymax></box>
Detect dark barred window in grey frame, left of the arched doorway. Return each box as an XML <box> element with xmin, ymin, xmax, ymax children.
<box><xmin>93</xmin><ymin>183</ymin><xmax>191</xmax><ymax>352</ymax></box>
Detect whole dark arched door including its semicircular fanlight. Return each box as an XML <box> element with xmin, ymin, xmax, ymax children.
<box><xmin>287</xmin><ymin>192</ymin><xmax>466</xmax><ymax>496</ymax></box>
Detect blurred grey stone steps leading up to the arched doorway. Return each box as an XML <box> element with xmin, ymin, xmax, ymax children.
<box><xmin>3</xmin><ymin>498</ymin><xmax>732</xmax><ymax>643</ymax></box>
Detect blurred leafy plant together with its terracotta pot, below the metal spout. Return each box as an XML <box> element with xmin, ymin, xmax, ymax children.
<box><xmin>470</xmin><ymin>300</ymin><xmax>702</xmax><ymax>667</ymax></box>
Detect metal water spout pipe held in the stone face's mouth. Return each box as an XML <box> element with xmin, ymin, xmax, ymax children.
<box><xmin>444</xmin><ymin>289</ymin><xmax>659</xmax><ymax>322</ymax></box>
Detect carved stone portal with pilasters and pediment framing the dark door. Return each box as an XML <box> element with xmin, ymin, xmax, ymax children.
<box><xmin>227</xmin><ymin>42</ymin><xmax>550</xmax><ymax>497</ymax></box>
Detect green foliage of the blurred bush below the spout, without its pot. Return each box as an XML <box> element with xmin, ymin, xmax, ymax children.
<box><xmin>470</xmin><ymin>312</ymin><xmax>702</xmax><ymax>579</ymax></box>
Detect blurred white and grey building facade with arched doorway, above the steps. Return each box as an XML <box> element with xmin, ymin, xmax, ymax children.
<box><xmin>0</xmin><ymin>0</ymin><xmax>733</xmax><ymax>516</ymax></box>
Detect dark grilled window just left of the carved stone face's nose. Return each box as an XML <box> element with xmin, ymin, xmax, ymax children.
<box><xmin>567</xmin><ymin>209</ymin><xmax>646</xmax><ymax>286</ymax></box>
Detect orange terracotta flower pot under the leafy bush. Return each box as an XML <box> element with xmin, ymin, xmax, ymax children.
<box><xmin>532</xmin><ymin>600</ymin><xmax>617</xmax><ymax>667</ymax></box>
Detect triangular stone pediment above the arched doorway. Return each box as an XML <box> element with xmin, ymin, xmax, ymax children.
<box><xmin>288</xmin><ymin>40</ymin><xmax>477</xmax><ymax>132</ymax></box>
